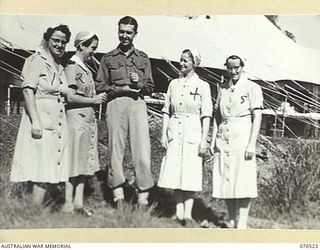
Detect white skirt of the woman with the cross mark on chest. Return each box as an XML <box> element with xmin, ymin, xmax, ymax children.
<box><xmin>158</xmin><ymin>113</ymin><xmax>202</xmax><ymax>191</ymax></box>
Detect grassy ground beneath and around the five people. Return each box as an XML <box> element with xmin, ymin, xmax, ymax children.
<box><xmin>0</xmin><ymin>112</ymin><xmax>320</xmax><ymax>229</ymax></box>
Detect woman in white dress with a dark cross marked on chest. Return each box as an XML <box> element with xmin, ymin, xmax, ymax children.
<box><xmin>158</xmin><ymin>49</ymin><xmax>212</xmax><ymax>226</ymax></box>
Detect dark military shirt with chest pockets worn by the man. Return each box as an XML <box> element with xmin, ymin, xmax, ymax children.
<box><xmin>96</xmin><ymin>47</ymin><xmax>154</xmax><ymax>95</ymax></box>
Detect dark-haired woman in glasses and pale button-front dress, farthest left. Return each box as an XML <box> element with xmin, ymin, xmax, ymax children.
<box><xmin>10</xmin><ymin>25</ymin><xmax>71</xmax><ymax>204</ymax></box>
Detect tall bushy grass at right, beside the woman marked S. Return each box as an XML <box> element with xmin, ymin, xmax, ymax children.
<box><xmin>259</xmin><ymin>138</ymin><xmax>320</xmax><ymax>215</ymax></box>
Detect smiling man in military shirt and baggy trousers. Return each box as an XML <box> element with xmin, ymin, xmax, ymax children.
<box><xmin>96</xmin><ymin>16</ymin><xmax>154</xmax><ymax>208</ymax></box>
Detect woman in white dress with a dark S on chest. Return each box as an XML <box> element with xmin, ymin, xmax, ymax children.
<box><xmin>210</xmin><ymin>55</ymin><xmax>263</xmax><ymax>228</ymax></box>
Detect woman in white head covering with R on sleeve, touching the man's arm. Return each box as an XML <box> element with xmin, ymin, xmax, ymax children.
<box><xmin>63</xmin><ymin>31</ymin><xmax>106</xmax><ymax>216</ymax></box>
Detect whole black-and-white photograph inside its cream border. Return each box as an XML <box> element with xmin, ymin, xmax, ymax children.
<box><xmin>0</xmin><ymin>11</ymin><xmax>320</xmax><ymax>235</ymax></box>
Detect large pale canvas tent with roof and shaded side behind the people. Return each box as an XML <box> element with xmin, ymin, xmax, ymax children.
<box><xmin>0</xmin><ymin>15</ymin><xmax>320</xmax><ymax>138</ymax></box>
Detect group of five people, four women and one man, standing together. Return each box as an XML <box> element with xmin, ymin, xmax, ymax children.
<box><xmin>10</xmin><ymin>16</ymin><xmax>263</xmax><ymax>228</ymax></box>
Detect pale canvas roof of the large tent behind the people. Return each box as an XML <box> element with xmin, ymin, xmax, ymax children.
<box><xmin>0</xmin><ymin>15</ymin><xmax>320</xmax><ymax>84</ymax></box>
